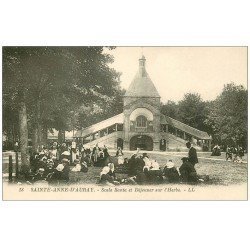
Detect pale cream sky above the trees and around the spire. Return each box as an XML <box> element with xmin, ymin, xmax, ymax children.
<box><xmin>108</xmin><ymin>47</ymin><xmax>247</xmax><ymax>102</ymax></box>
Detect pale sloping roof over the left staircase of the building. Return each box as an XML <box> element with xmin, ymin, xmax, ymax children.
<box><xmin>75</xmin><ymin>113</ymin><xmax>124</xmax><ymax>137</ymax></box>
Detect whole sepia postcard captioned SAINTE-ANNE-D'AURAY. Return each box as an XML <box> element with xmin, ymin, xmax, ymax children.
<box><xmin>2</xmin><ymin>46</ymin><xmax>248</xmax><ymax>200</ymax></box>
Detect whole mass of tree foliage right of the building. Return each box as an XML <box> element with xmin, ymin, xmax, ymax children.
<box><xmin>161</xmin><ymin>83</ymin><xmax>247</xmax><ymax>148</ymax></box>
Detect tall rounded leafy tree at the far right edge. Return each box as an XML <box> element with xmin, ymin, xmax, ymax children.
<box><xmin>206</xmin><ymin>83</ymin><xmax>247</xmax><ymax>148</ymax></box>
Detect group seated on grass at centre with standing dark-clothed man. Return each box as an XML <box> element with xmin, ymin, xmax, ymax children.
<box><xmin>99</xmin><ymin>142</ymin><xmax>204</xmax><ymax>186</ymax></box>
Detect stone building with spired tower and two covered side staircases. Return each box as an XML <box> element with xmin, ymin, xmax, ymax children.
<box><xmin>75</xmin><ymin>56</ymin><xmax>211</xmax><ymax>151</ymax></box>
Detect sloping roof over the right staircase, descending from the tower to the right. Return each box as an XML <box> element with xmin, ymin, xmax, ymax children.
<box><xmin>161</xmin><ymin>116</ymin><xmax>211</xmax><ymax>140</ymax></box>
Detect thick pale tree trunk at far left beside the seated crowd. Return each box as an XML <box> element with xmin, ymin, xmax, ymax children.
<box><xmin>19</xmin><ymin>101</ymin><xmax>30</xmax><ymax>173</ymax></box>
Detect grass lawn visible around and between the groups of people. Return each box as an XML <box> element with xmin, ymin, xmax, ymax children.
<box><xmin>2</xmin><ymin>151</ymin><xmax>248</xmax><ymax>185</ymax></box>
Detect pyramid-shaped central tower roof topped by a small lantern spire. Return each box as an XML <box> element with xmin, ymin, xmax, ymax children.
<box><xmin>125</xmin><ymin>56</ymin><xmax>160</xmax><ymax>97</ymax></box>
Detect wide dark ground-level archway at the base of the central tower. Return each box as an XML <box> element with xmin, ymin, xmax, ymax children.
<box><xmin>130</xmin><ymin>135</ymin><xmax>153</xmax><ymax>151</ymax></box>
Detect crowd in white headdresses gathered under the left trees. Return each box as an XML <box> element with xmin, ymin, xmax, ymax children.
<box><xmin>26</xmin><ymin>141</ymin><xmax>109</xmax><ymax>184</ymax></box>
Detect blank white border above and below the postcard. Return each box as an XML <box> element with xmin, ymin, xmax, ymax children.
<box><xmin>0</xmin><ymin>0</ymin><xmax>250</xmax><ymax>249</ymax></box>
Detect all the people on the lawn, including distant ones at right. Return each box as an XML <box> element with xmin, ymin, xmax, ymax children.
<box><xmin>18</xmin><ymin>141</ymin><xmax>244</xmax><ymax>185</ymax></box>
